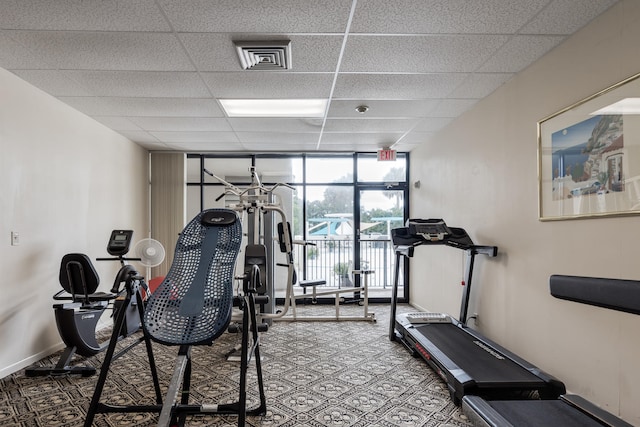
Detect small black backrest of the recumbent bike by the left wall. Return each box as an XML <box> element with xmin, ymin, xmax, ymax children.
<box><xmin>59</xmin><ymin>254</ymin><xmax>100</xmax><ymax>300</ymax></box>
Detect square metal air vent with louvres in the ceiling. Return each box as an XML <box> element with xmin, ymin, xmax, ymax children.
<box><xmin>233</xmin><ymin>40</ymin><xmax>291</xmax><ymax>70</ymax></box>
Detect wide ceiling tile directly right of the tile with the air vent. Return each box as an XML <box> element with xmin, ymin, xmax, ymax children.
<box><xmin>340</xmin><ymin>34</ymin><xmax>509</xmax><ymax>73</ymax></box>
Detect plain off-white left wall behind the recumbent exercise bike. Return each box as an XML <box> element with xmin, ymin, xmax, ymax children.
<box><xmin>0</xmin><ymin>69</ymin><xmax>149</xmax><ymax>377</ymax></box>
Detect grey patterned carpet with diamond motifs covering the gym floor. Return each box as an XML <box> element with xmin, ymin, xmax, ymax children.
<box><xmin>0</xmin><ymin>305</ymin><xmax>470</xmax><ymax>427</ymax></box>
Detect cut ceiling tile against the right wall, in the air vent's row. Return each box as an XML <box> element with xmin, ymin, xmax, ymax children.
<box><xmin>478</xmin><ymin>36</ymin><xmax>566</xmax><ymax>73</ymax></box>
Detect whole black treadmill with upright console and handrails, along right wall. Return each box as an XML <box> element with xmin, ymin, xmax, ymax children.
<box><xmin>389</xmin><ymin>219</ymin><xmax>566</xmax><ymax>405</ymax></box>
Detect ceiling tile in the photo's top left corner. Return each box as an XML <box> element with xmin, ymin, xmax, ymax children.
<box><xmin>0</xmin><ymin>0</ymin><xmax>171</xmax><ymax>31</ymax></box>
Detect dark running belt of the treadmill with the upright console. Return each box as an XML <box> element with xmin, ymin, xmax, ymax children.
<box><xmin>412</xmin><ymin>323</ymin><xmax>544</xmax><ymax>387</ymax></box>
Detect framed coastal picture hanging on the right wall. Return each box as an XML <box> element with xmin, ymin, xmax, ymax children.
<box><xmin>538</xmin><ymin>74</ymin><xmax>640</xmax><ymax>221</ymax></box>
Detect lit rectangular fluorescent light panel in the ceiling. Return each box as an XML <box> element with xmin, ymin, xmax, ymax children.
<box><xmin>220</xmin><ymin>99</ymin><xmax>328</xmax><ymax>117</ymax></box>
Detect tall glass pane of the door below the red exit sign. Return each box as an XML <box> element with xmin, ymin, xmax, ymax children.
<box><xmin>355</xmin><ymin>187</ymin><xmax>406</xmax><ymax>301</ymax></box>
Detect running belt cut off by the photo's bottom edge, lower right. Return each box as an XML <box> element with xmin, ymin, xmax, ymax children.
<box><xmin>488</xmin><ymin>400</ymin><xmax>602</xmax><ymax>427</ymax></box>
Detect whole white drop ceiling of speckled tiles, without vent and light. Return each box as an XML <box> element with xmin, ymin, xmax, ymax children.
<box><xmin>0</xmin><ymin>0</ymin><xmax>616</xmax><ymax>152</ymax></box>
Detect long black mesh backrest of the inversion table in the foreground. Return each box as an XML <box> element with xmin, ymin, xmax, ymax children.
<box><xmin>143</xmin><ymin>209</ymin><xmax>242</xmax><ymax>345</ymax></box>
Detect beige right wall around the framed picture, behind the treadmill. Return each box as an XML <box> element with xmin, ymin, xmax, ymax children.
<box><xmin>411</xmin><ymin>0</ymin><xmax>640</xmax><ymax>425</ymax></box>
